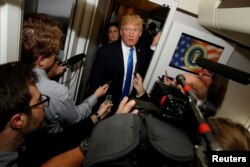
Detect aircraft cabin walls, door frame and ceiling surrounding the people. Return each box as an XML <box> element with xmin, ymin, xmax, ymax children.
<box><xmin>0</xmin><ymin>0</ymin><xmax>250</xmax><ymax>134</ymax></box>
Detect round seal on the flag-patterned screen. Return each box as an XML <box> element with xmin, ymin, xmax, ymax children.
<box><xmin>184</xmin><ymin>44</ymin><xmax>207</xmax><ymax>70</ymax></box>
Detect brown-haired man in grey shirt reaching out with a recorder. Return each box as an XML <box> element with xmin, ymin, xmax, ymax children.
<box><xmin>22</xmin><ymin>13</ymin><xmax>109</xmax><ymax>133</ymax></box>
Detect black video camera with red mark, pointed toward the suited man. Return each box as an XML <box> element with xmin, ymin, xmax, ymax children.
<box><xmin>136</xmin><ymin>81</ymin><xmax>216</xmax><ymax>123</ymax></box>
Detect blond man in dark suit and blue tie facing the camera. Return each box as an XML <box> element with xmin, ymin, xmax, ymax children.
<box><xmin>88</xmin><ymin>15</ymin><xmax>153</xmax><ymax>114</ymax></box>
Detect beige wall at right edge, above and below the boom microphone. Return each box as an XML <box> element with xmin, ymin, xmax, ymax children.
<box><xmin>218</xmin><ymin>46</ymin><xmax>250</xmax><ymax>128</ymax></box>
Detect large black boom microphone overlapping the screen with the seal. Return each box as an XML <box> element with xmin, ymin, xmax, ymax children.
<box><xmin>195</xmin><ymin>57</ymin><xmax>250</xmax><ymax>85</ymax></box>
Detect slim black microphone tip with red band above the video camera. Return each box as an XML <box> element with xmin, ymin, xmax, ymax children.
<box><xmin>176</xmin><ymin>74</ymin><xmax>198</xmax><ymax>101</ymax></box>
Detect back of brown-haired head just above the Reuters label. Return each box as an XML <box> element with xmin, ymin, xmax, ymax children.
<box><xmin>193</xmin><ymin>117</ymin><xmax>250</xmax><ymax>167</ymax></box>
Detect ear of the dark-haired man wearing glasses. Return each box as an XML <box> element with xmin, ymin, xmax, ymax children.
<box><xmin>10</xmin><ymin>113</ymin><xmax>27</xmax><ymax>130</ymax></box>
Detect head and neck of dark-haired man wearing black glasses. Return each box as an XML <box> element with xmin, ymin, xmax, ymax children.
<box><xmin>0</xmin><ymin>62</ymin><xmax>43</xmax><ymax>167</ymax></box>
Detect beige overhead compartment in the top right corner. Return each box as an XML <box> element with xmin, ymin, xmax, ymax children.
<box><xmin>198</xmin><ymin>0</ymin><xmax>250</xmax><ymax>47</ymax></box>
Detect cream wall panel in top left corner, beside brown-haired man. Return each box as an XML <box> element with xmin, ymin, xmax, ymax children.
<box><xmin>0</xmin><ymin>0</ymin><xmax>23</xmax><ymax>64</ymax></box>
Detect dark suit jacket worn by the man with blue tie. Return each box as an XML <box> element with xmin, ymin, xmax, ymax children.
<box><xmin>88</xmin><ymin>41</ymin><xmax>153</xmax><ymax>114</ymax></box>
